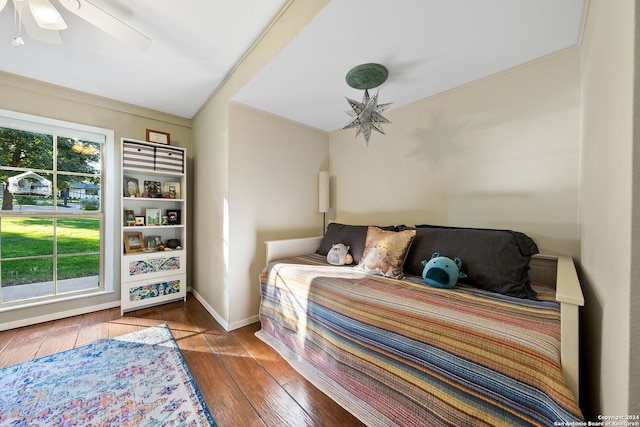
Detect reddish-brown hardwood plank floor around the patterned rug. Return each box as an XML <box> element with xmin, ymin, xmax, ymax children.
<box><xmin>0</xmin><ymin>294</ymin><xmax>363</xmax><ymax>427</ymax></box>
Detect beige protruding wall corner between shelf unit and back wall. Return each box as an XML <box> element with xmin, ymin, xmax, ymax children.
<box><xmin>189</xmin><ymin>100</ymin><xmax>329</xmax><ymax>329</ymax></box>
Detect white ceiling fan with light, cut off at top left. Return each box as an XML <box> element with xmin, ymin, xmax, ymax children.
<box><xmin>0</xmin><ymin>0</ymin><xmax>151</xmax><ymax>51</ymax></box>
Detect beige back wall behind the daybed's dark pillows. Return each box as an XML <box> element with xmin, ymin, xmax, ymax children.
<box><xmin>330</xmin><ymin>49</ymin><xmax>580</xmax><ymax>256</ymax></box>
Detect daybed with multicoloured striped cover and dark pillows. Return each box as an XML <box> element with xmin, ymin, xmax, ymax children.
<box><xmin>256</xmin><ymin>224</ymin><xmax>584</xmax><ymax>426</ymax></box>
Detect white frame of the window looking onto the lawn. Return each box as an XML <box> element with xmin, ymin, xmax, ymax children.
<box><xmin>0</xmin><ymin>109</ymin><xmax>119</xmax><ymax>313</ymax></box>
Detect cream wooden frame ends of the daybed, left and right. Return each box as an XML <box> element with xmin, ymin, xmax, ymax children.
<box><xmin>265</xmin><ymin>236</ymin><xmax>584</xmax><ymax>401</ymax></box>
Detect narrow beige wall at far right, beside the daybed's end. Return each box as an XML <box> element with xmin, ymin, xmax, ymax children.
<box><xmin>580</xmin><ymin>0</ymin><xmax>640</xmax><ymax>417</ymax></box>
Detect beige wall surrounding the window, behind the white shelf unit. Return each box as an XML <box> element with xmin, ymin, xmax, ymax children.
<box><xmin>0</xmin><ymin>73</ymin><xmax>191</xmax><ymax>329</ymax></box>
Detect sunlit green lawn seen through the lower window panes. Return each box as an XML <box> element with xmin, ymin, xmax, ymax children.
<box><xmin>0</xmin><ymin>217</ymin><xmax>100</xmax><ymax>286</ymax></box>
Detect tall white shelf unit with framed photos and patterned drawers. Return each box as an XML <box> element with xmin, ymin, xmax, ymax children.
<box><xmin>120</xmin><ymin>138</ymin><xmax>188</xmax><ymax>313</ymax></box>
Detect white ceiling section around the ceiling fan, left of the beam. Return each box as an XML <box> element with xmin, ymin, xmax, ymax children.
<box><xmin>0</xmin><ymin>0</ymin><xmax>285</xmax><ymax>118</ymax></box>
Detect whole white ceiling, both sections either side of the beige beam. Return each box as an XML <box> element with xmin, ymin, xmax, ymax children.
<box><xmin>0</xmin><ymin>0</ymin><xmax>584</xmax><ymax>131</ymax></box>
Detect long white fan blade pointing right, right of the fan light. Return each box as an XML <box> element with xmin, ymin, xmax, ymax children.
<box><xmin>59</xmin><ymin>0</ymin><xmax>151</xmax><ymax>52</ymax></box>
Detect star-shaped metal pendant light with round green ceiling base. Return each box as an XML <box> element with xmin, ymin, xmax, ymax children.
<box><xmin>343</xmin><ymin>64</ymin><xmax>392</xmax><ymax>146</ymax></box>
